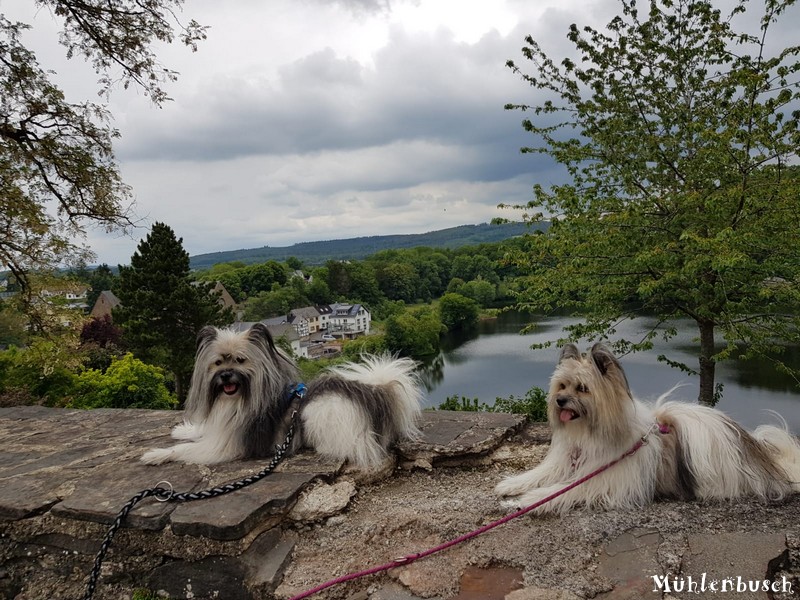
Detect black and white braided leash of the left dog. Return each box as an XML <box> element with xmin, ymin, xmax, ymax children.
<box><xmin>83</xmin><ymin>383</ymin><xmax>306</xmax><ymax>600</ymax></box>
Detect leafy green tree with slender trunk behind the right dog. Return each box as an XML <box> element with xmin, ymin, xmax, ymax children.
<box><xmin>507</xmin><ymin>0</ymin><xmax>800</xmax><ymax>404</ymax></box>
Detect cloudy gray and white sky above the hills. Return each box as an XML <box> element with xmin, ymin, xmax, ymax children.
<box><xmin>6</xmin><ymin>0</ymin><xmax>788</xmax><ymax>265</ymax></box>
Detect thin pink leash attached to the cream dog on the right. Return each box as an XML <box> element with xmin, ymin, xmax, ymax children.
<box><xmin>289</xmin><ymin>425</ymin><xmax>656</xmax><ymax>600</ymax></box>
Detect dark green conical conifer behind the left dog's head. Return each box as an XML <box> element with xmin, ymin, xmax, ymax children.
<box><xmin>113</xmin><ymin>223</ymin><xmax>228</xmax><ymax>402</ymax></box>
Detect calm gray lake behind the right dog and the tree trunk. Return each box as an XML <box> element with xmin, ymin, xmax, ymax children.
<box><xmin>422</xmin><ymin>312</ymin><xmax>800</xmax><ymax>435</ymax></box>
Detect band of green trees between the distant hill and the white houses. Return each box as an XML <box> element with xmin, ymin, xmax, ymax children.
<box><xmin>195</xmin><ymin>239</ymin><xmax>523</xmax><ymax>321</ymax></box>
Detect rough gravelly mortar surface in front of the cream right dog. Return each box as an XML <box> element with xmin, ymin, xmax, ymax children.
<box><xmin>276</xmin><ymin>436</ymin><xmax>800</xmax><ymax>599</ymax></box>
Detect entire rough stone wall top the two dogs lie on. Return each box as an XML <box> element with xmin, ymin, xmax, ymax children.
<box><xmin>0</xmin><ymin>408</ymin><xmax>800</xmax><ymax>600</ymax></box>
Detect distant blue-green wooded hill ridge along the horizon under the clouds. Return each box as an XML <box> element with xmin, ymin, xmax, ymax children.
<box><xmin>190</xmin><ymin>223</ymin><xmax>544</xmax><ymax>269</ymax></box>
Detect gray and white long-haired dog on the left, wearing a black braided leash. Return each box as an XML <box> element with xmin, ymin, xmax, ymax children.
<box><xmin>141</xmin><ymin>323</ymin><xmax>421</xmax><ymax>469</ymax></box>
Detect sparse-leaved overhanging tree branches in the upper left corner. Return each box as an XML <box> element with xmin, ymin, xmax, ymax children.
<box><xmin>0</xmin><ymin>0</ymin><xmax>205</xmax><ymax>318</ymax></box>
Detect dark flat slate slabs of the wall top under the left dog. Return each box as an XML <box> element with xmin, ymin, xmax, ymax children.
<box><xmin>0</xmin><ymin>407</ymin><xmax>524</xmax><ymax>600</ymax></box>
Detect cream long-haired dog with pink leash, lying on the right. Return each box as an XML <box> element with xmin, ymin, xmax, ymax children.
<box><xmin>496</xmin><ymin>345</ymin><xmax>800</xmax><ymax>514</ymax></box>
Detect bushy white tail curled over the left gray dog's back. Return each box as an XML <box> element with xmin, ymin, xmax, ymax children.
<box><xmin>330</xmin><ymin>354</ymin><xmax>422</xmax><ymax>439</ymax></box>
